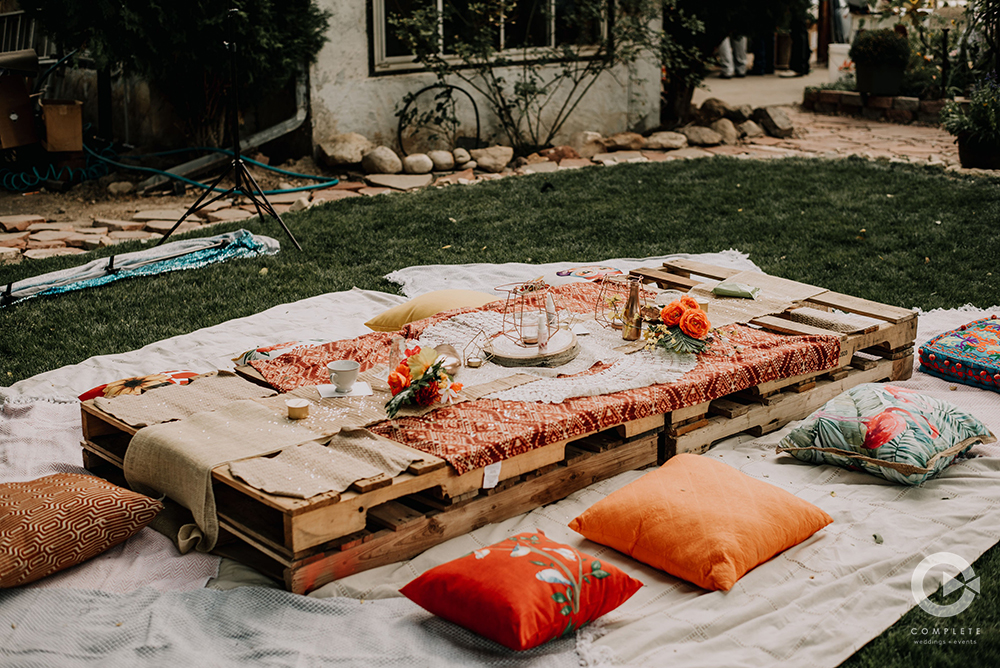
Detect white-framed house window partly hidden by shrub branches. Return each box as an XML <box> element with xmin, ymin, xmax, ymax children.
<box><xmin>369</xmin><ymin>0</ymin><xmax>611</xmax><ymax>72</ymax></box>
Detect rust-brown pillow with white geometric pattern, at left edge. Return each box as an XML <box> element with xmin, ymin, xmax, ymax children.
<box><xmin>0</xmin><ymin>473</ymin><xmax>163</xmax><ymax>588</ymax></box>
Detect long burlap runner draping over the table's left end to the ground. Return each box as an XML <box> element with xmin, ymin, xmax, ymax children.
<box><xmin>124</xmin><ymin>400</ymin><xmax>321</xmax><ymax>552</ymax></box>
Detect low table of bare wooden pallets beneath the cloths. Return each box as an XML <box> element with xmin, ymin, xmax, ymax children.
<box><xmin>82</xmin><ymin>261</ymin><xmax>916</xmax><ymax>593</ymax></box>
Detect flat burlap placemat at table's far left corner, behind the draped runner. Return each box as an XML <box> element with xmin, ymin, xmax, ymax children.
<box><xmin>94</xmin><ymin>371</ymin><xmax>276</xmax><ymax>427</ymax></box>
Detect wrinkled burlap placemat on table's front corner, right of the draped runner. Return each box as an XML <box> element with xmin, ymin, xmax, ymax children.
<box><xmin>229</xmin><ymin>427</ymin><xmax>423</xmax><ymax>499</ymax></box>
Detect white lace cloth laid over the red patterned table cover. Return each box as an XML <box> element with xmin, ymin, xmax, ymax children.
<box><xmin>420</xmin><ymin>311</ymin><xmax>697</xmax><ymax>404</ymax></box>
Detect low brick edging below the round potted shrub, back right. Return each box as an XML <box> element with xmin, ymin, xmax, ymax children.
<box><xmin>802</xmin><ymin>90</ymin><xmax>965</xmax><ymax>125</ymax></box>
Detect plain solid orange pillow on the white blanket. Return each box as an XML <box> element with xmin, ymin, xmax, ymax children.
<box><xmin>569</xmin><ymin>454</ymin><xmax>833</xmax><ymax>591</ymax></box>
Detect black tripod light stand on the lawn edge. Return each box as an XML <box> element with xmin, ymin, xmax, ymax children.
<box><xmin>156</xmin><ymin>7</ymin><xmax>302</xmax><ymax>250</ymax></box>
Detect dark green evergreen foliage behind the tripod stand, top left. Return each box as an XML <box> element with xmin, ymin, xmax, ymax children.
<box><xmin>20</xmin><ymin>0</ymin><xmax>329</xmax><ymax>146</ymax></box>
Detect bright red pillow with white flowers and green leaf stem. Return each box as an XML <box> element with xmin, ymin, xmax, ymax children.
<box><xmin>400</xmin><ymin>531</ymin><xmax>642</xmax><ymax>650</ymax></box>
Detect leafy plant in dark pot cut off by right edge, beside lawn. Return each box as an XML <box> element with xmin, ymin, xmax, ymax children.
<box><xmin>941</xmin><ymin>71</ymin><xmax>1000</xmax><ymax>169</ymax></box>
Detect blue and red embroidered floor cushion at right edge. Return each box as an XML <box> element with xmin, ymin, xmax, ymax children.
<box><xmin>920</xmin><ymin>315</ymin><xmax>1000</xmax><ymax>392</ymax></box>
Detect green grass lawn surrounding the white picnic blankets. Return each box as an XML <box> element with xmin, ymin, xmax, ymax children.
<box><xmin>0</xmin><ymin>158</ymin><xmax>1000</xmax><ymax>668</ymax></box>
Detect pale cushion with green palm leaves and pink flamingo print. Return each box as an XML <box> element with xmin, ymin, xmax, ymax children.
<box><xmin>778</xmin><ymin>383</ymin><xmax>996</xmax><ymax>485</ymax></box>
